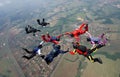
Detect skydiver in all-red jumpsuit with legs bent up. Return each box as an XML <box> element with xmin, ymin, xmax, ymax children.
<box><xmin>64</xmin><ymin>23</ymin><xmax>88</xmax><ymax>42</ymax></box>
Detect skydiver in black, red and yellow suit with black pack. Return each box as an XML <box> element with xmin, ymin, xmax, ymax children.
<box><xmin>70</xmin><ymin>42</ymin><xmax>102</xmax><ymax>64</ymax></box>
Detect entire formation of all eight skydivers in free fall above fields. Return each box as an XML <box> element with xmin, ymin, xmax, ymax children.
<box><xmin>22</xmin><ymin>18</ymin><xmax>108</xmax><ymax>65</ymax></box>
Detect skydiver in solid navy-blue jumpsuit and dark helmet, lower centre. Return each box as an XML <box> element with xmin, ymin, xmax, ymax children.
<box><xmin>41</xmin><ymin>44</ymin><xmax>69</xmax><ymax>65</ymax></box>
